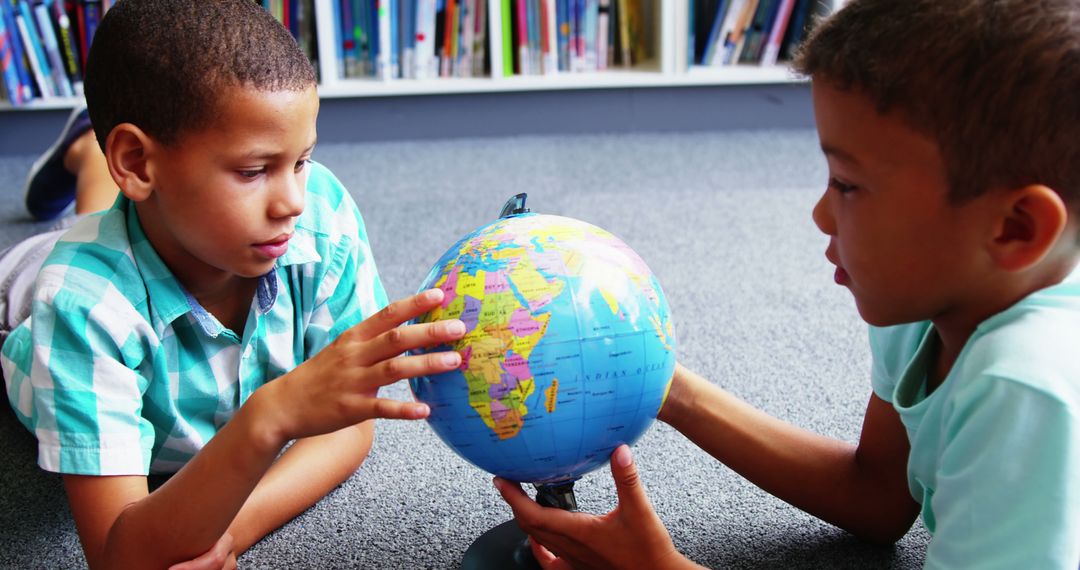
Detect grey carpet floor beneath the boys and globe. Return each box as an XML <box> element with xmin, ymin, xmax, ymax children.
<box><xmin>0</xmin><ymin>131</ymin><xmax>929</xmax><ymax>569</ymax></box>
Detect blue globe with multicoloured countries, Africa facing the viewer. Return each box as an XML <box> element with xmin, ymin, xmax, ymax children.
<box><xmin>409</xmin><ymin>199</ymin><xmax>675</xmax><ymax>486</ymax></box>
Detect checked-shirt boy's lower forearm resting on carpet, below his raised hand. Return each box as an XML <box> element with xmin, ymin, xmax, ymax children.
<box><xmin>229</xmin><ymin>421</ymin><xmax>375</xmax><ymax>554</ymax></box>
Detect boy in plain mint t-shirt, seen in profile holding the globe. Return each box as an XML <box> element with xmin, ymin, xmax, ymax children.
<box><xmin>496</xmin><ymin>0</ymin><xmax>1080</xmax><ymax>570</ymax></box>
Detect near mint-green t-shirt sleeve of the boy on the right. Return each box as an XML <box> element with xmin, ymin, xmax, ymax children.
<box><xmin>926</xmin><ymin>376</ymin><xmax>1080</xmax><ymax>570</ymax></box>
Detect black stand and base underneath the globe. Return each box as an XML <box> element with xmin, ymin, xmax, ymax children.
<box><xmin>461</xmin><ymin>481</ymin><xmax>578</xmax><ymax>570</ymax></box>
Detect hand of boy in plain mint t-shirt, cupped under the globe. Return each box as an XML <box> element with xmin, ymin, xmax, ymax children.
<box><xmin>495</xmin><ymin>445</ymin><xmax>697</xmax><ymax>569</ymax></box>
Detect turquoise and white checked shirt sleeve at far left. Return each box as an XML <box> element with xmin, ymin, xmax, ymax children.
<box><xmin>28</xmin><ymin>280</ymin><xmax>154</xmax><ymax>475</ymax></box>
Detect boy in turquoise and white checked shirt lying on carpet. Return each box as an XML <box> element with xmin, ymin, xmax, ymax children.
<box><xmin>2</xmin><ymin>0</ymin><xmax>464</xmax><ymax>568</ymax></box>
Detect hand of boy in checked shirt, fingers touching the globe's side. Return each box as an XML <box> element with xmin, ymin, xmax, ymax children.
<box><xmin>260</xmin><ymin>289</ymin><xmax>465</xmax><ymax>443</ymax></box>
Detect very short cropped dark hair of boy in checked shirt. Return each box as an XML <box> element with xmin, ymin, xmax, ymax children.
<box><xmin>85</xmin><ymin>0</ymin><xmax>315</xmax><ymax>149</ymax></box>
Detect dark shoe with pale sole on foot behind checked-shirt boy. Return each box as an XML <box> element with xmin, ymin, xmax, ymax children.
<box><xmin>24</xmin><ymin>106</ymin><xmax>91</xmax><ymax>220</ymax></box>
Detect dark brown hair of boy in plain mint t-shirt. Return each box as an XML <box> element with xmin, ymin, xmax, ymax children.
<box><xmin>795</xmin><ymin>0</ymin><xmax>1080</xmax><ymax>211</ymax></box>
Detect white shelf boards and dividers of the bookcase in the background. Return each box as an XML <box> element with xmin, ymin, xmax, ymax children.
<box><xmin>0</xmin><ymin>0</ymin><xmax>846</xmax><ymax>107</ymax></box>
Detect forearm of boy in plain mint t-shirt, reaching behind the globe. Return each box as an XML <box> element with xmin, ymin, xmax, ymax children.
<box><xmin>660</xmin><ymin>366</ymin><xmax>914</xmax><ymax>542</ymax></box>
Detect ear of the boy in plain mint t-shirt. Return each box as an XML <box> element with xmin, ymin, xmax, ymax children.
<box><xmin>990</xmin><ymin>185</ymin><xmax>1068</xmax><ymax>271</ymax></box>
